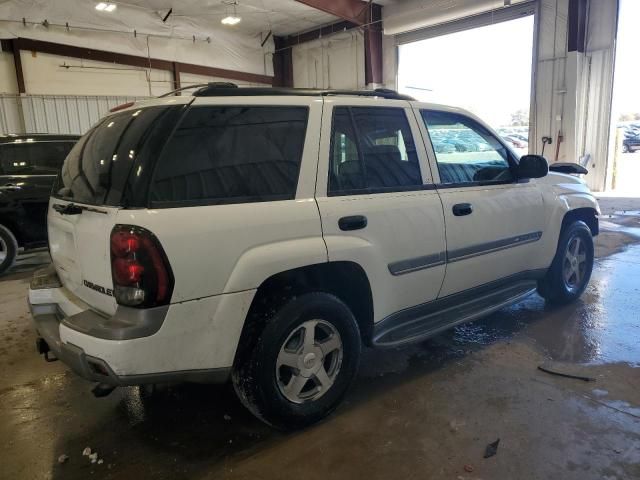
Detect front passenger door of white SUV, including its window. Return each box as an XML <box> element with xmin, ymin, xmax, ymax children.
<box><xmin>416</xmin><ymin>106</ymin><xmax>544</xmax><ymax>297</ymax></box>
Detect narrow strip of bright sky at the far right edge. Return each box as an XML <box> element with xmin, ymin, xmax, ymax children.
<box><xmin>613</xmin><ymin>0</ymin><xmax>640</xmax><ymax>120</ymax></box>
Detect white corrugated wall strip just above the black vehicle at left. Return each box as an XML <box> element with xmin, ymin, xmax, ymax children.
<box><xmin>0</xmin><ymin>95</ymin><xmax>142</xmax><ymax>134</ymax></box>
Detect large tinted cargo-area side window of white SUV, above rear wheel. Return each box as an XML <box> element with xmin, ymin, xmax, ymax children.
<box><xmin>151</xmin><ymin>106</ymin><xmax>308</xmax><ymax>207</ymax></box>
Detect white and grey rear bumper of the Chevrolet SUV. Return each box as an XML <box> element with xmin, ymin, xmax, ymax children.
<box><xmin>29</xmin><ymin>271</ymin><xmax>254</xmax><ymax>386</ymax></box>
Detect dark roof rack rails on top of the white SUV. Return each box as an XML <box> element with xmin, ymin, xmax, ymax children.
<box><xmin>188</xmin><ymin>82</ymin><xmax>415</xmax><ymax>101</ymax></box>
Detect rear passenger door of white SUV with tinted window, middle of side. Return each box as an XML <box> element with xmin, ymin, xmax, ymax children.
<box><xmin>316</xmin><ymin>97</ymin><xmax>445</xmax><ymax>321</ymax></box>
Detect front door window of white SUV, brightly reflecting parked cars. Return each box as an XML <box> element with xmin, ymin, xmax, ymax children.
<box><xmin>421</xmin><ymin>110</ymin><xmax>513</xmax><ymax>184</ymax></box>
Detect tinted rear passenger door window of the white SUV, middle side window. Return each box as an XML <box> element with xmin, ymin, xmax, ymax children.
<box><xmin>329</xmin><ymin>107</ymin><xmax>422</xmax><ymax>195</ymax></box>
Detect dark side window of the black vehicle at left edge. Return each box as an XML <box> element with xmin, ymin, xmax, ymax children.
<box><xmin>0</xmin><ymin>141</ymin><xmax>73</xmax><ymax>175</ymax></box>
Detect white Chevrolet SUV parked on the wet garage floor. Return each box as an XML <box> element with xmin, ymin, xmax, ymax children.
<box><xmin>29</xmin><ymin>84</ymin><xmax>599</xmax><ymax>427</ymax></box>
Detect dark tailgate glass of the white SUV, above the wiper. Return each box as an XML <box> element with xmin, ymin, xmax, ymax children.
<box><xmin>54</xmin><ymin>106</ymin><xmax>177</xmax><ymax>206</ymax></box>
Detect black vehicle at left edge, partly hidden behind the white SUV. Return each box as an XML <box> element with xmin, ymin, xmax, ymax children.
<box><xmin>0</xmin><ymin>134</ymin><xmax>80</xmax><ymax>274</ymax></box>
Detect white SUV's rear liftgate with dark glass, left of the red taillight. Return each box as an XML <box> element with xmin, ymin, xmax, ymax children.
<box><xmin>48</xmin><ymin>100</ymin><xmax>186</xmax><ymax>314</ymax></box>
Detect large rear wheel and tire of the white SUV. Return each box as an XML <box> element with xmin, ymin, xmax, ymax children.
<box><xmin>232</xmin><ymin>292</ymin><xmax>361</xmax><ymax>430</ymax></box>
